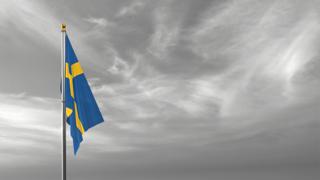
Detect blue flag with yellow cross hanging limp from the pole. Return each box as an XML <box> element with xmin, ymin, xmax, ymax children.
<box><xmin>65</xmin><ymin>35</ymin><xmax>103</xmax><ymax>154</ymax></box>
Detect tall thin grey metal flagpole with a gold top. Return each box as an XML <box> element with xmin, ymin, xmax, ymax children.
<box><xmin>61</xmin><ymin>24</ymin><xmax>67</xmax><ymax>180</ymax></box>
